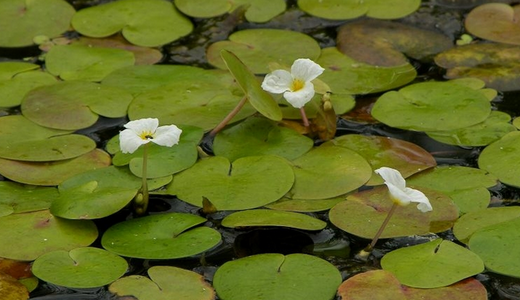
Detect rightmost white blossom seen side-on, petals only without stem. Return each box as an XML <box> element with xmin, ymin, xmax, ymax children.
<box><xmin>375</xmin><ymin>167</ymin><xmax>433</xmax><ymax>212</ymax></box>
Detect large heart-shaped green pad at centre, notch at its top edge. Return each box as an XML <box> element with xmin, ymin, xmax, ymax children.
<box><xmin>167</xmin><ymin>155</ymin><xmax>294</xmax><ymax>210</ymax></box>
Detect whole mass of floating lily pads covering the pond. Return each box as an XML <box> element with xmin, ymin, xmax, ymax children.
<box><xmin>0</xmin><ymin>0</ymin><xmax>520</xmax><ymax>300</ymax></box>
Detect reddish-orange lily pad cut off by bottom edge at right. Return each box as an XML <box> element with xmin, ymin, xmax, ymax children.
<box><xmin>338</xmin><ymin>270</ymin><xmax>488</xmax><ymax>300</ymax></box>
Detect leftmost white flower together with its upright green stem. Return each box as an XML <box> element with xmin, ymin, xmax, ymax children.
<box><xmin>119</xmin><ymin>118</ymin><xmax>182</xmax><ymax>215</ymax></box>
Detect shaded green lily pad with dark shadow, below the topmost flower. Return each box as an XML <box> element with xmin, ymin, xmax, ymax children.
<box><xmin>213</xmin><ymin>117</ymin><xmax>314</xmax><ymax>161</ymax></box>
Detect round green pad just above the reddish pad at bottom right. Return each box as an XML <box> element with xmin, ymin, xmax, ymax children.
<box><xmin>381</xmin><ymin>239</ymin><xmax>484</xmax><ymax>288</ymax></box>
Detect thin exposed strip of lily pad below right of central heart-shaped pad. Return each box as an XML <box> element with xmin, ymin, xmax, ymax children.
<box><xmin>265</xmin><ymin>196</ymin><xmax>345</xmax><ymax>212</ymax></box>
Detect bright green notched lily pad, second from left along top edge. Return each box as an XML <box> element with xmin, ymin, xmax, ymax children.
<box><xmin>72</xmin><ymin>0</ymin><xmax>193</xmax><ymax>47</ymax></box>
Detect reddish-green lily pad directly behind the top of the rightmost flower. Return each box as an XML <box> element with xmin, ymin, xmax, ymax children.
<box><xmin>327</xmin><ymin>134</ymin><xmax>437</xmax><ymax>185</ymax></box>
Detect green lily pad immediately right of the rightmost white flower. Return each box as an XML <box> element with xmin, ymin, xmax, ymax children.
<box><xmin>408</xmin><ymin>166</ymin><xmax>498</xmax><ymax>214</ymax></box>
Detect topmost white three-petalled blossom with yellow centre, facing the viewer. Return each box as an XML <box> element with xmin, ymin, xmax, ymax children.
<box><xmin>262</xmin><ymin>58</ymin><xmax>325</xmax><ymax>108</ymax></box>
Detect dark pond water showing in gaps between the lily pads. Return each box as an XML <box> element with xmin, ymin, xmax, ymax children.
<box><xmin>0</xmin><ymin>0</ymin><xmax>520</xmax><ymax>300</ymax></box>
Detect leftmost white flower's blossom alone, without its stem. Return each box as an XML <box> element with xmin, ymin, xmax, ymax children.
<box><xmin>119</xmin><ymin>118</ymin><xmax>182</xmax><ymax>153</ymax></box>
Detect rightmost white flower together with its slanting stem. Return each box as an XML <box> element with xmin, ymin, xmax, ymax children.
<box><xmin>360</xmin><ymin>167</ymin><xmax>433</xmax><ymax>257</ymax></box>
